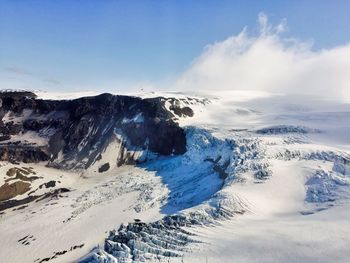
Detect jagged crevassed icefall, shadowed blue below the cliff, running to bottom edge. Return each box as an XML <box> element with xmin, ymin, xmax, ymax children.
<box><xmin>81</xmin><ymin>127</ymin><xmax>270</xmax><ymax>263</ymax></box>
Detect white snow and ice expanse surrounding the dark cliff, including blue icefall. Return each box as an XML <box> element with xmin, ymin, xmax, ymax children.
<box><xmin>0</xmin><ymin>91</ymin><xmax>350</xmax><ymax>262</ymax></box>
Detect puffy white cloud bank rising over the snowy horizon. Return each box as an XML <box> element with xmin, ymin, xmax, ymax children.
<box><xmin>175</xmin><ymin>13</ymin><xmax>350</xmax><ymax>100</ymax></box>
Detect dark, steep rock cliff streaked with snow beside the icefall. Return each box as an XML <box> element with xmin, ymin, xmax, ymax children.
<box><xmin>0</xmin><ymin>92</ymin><xmax>189</xmax><ymax>169</ymax></box>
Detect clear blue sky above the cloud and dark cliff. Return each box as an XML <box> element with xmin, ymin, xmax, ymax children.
<box><xmin>0</xmin><ymin>0</ymin><xmax>350</xmax><ymax>91</ymax></box>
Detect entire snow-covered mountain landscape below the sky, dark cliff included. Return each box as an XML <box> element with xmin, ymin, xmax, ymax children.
<box><xmin>0</xmin><ymin>91</ymin><xmax>350</xmax><ymax>263</ymax></box>
